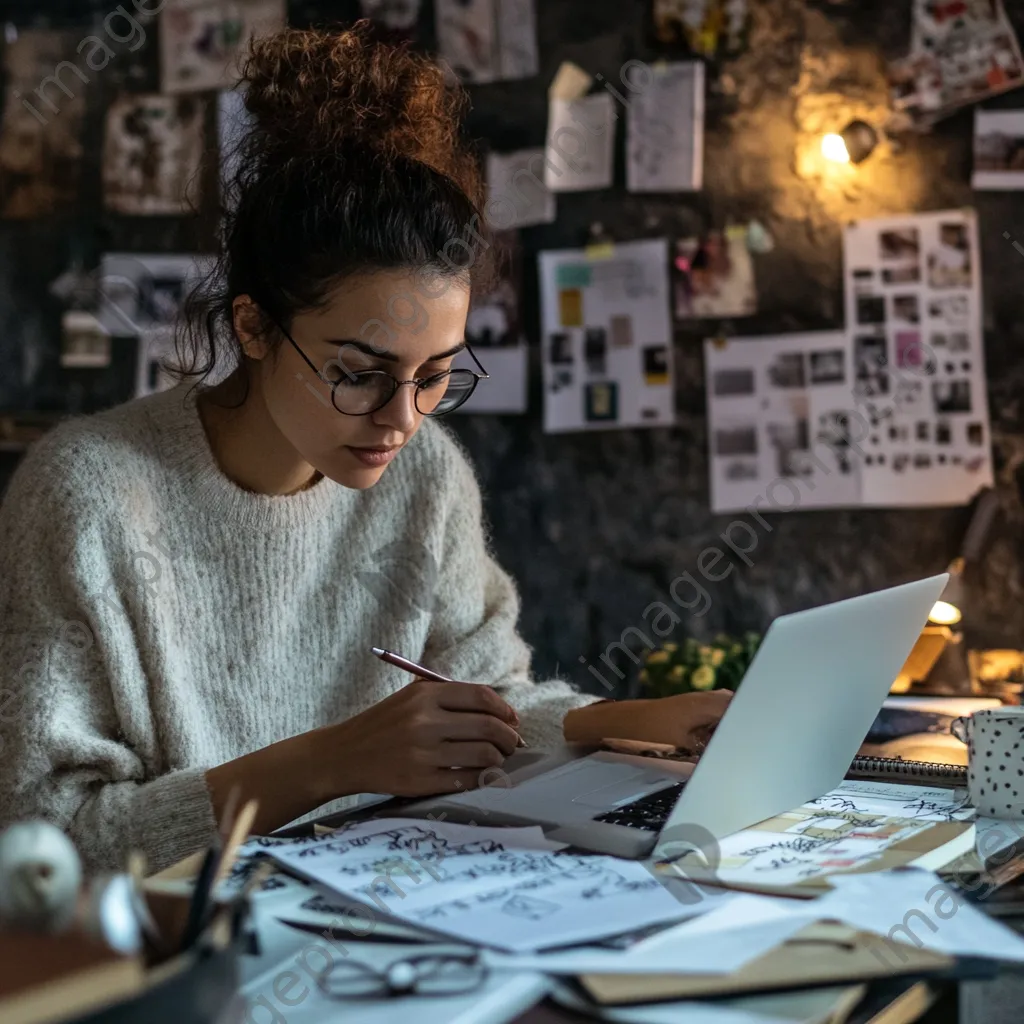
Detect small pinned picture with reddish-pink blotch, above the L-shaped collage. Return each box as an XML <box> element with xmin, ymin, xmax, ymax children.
<box><xmin>674</xmin><ymin>224</ymin><xmax>758</xmax><ymax>319</ymax></box>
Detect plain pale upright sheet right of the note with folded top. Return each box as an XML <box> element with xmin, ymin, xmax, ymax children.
<box><xmin>626</xmin><ymin>60</ymin><xmax>705</xmax><ymax>193</ymax></box>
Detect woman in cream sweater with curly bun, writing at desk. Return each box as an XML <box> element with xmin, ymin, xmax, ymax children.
<box><xmin>0</xmin><ymin>27</ymin><xmax>725</xmax><ymax>869</ymax></box>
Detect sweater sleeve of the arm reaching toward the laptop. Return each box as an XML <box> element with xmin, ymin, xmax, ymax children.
<box><xmin>424</xmin><ymin>432</ymin><xmax>601</xmax><ymax>746</ymax></box>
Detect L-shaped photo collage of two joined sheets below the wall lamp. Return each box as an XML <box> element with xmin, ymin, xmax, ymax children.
<box><xmin>705</xmin><ymin>210</ymin><xmax>992</xmax><ymax>513</ymax></box>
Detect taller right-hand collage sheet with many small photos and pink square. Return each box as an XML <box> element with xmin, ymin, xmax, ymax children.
<box><xmin>844</xmin><ymin>210</ymin><xmax>992</xmax><ymax>506</ymax></box>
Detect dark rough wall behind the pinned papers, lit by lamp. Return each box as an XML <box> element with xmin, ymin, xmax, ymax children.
<box><xmin>0</xmin><ymin>0</ymin><xmax>1024</xmax><ymax>694</ymax></box>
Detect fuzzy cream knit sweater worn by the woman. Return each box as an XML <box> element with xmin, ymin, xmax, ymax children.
<box><xmin>0</xmin><ymin>387</ymin><xmax>597</xmax><ymax>870</ymax></box>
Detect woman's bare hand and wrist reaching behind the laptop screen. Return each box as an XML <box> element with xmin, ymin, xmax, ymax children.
<box><xmin>562</xmin><ymin>690</ymin><xmax>732</xmax><ymax>754</ymax></box>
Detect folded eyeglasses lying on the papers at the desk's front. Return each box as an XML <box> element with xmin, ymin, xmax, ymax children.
<box><xmin>316</xmin><ymin>952</ymin><xmax>487</xmax><ymax>999</ymax></box>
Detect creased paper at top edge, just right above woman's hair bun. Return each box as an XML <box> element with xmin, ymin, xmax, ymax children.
<box><xmin>435</xmin><ymin>0</ymin><xmax>539</xmax><ymax>84</ymax></box>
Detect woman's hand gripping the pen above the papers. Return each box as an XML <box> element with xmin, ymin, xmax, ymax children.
<box><xmin>329</xmin><ymin>679</ymin><xmax>519</xmax><ymax>797</ymax></box>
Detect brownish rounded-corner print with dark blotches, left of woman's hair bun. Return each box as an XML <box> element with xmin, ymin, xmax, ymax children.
<box><xmin>102</xmin><ymin>94</ymin><xmax>206</xmax><ymax>216</ymax></box>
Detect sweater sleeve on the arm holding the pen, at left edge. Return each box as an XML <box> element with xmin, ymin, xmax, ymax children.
<box><xmin>0</xmin><ymin>436</ymin><xmax>214</xmax><ymax>872</ymax></box>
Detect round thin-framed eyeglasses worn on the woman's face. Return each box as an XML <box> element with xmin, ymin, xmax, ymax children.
<box><xmin>278</xmin><ymin>324</ymin><xmax>490</xmax><ymax>416</ymax></box>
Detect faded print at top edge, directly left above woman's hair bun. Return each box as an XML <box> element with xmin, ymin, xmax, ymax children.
<box><xmin>160</xmin><ymin>0</ymin><xmax>287</xmax><ymax>93</ymax></box>
